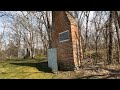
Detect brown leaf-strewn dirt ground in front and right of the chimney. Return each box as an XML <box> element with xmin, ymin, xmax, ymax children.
<box><xmin>55</xmin><ymin>59</ymin><xmax>120</xmax><ymax>79</ymax></box>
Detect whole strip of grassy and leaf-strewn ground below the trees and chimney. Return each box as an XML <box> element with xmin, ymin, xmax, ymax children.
<box><xmin>0</xmin><ymin>59</ymin><xmax>120</xmax><ymax>79</ymax></box>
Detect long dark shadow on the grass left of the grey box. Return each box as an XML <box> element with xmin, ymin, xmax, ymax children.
<box><xmin>10</xmin><ymin>61</ymin><xmax>52</xmax><ymax>73</ymax></box>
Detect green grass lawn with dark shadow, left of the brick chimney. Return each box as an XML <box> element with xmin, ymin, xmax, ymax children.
<box><xmin>0</xmin><ymin>59</ymin><xmax>55</xmax><ymax>79</ymax></box>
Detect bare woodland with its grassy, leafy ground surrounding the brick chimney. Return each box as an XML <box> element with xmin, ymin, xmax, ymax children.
<box><xmin>0</xmin><ymin>11</ymin><xmax>120</xmax><ymax>79</ymax></box>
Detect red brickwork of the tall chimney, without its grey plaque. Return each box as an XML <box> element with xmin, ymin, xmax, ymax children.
<box><xmin>52</xmin><ymin>11</ymin><xmax>78</xmax><ymax>70</ymax></box>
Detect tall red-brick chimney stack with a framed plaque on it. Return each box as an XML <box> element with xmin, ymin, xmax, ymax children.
<box><xmin>51</xmin><ymin>11</ymin><xmax>80</xmax><ymax>70</ymax></box>
